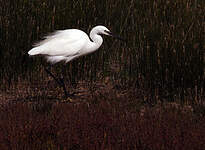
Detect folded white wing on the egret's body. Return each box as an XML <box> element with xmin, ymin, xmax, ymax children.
<box><xmin>28</xmin><ymin>29</ymin><xmax>89</xmax><ymax>57</ymax></box>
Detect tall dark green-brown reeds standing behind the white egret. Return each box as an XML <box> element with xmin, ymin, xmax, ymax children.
<box><xmin>0</xmin><ymin>0</ymin><xmax>205</xmax><ymax>103</ymax></box>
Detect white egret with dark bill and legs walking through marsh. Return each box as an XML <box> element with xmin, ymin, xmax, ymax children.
<box><xmin>28</xmin><ymin>25</ymin><xmax>123</xmax><ymax>97</ymax></box>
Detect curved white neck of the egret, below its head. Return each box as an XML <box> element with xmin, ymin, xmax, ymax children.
<box><xmin>90</xmin><ymin>28</ymin><xmax>103</xmax><ymax>50</ymax></box>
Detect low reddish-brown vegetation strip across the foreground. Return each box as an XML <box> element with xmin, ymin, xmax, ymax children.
<box><xmin>0</xmin><ymin>100</ymin><xmax>205</xmax><ymax>150</ymax></box>
